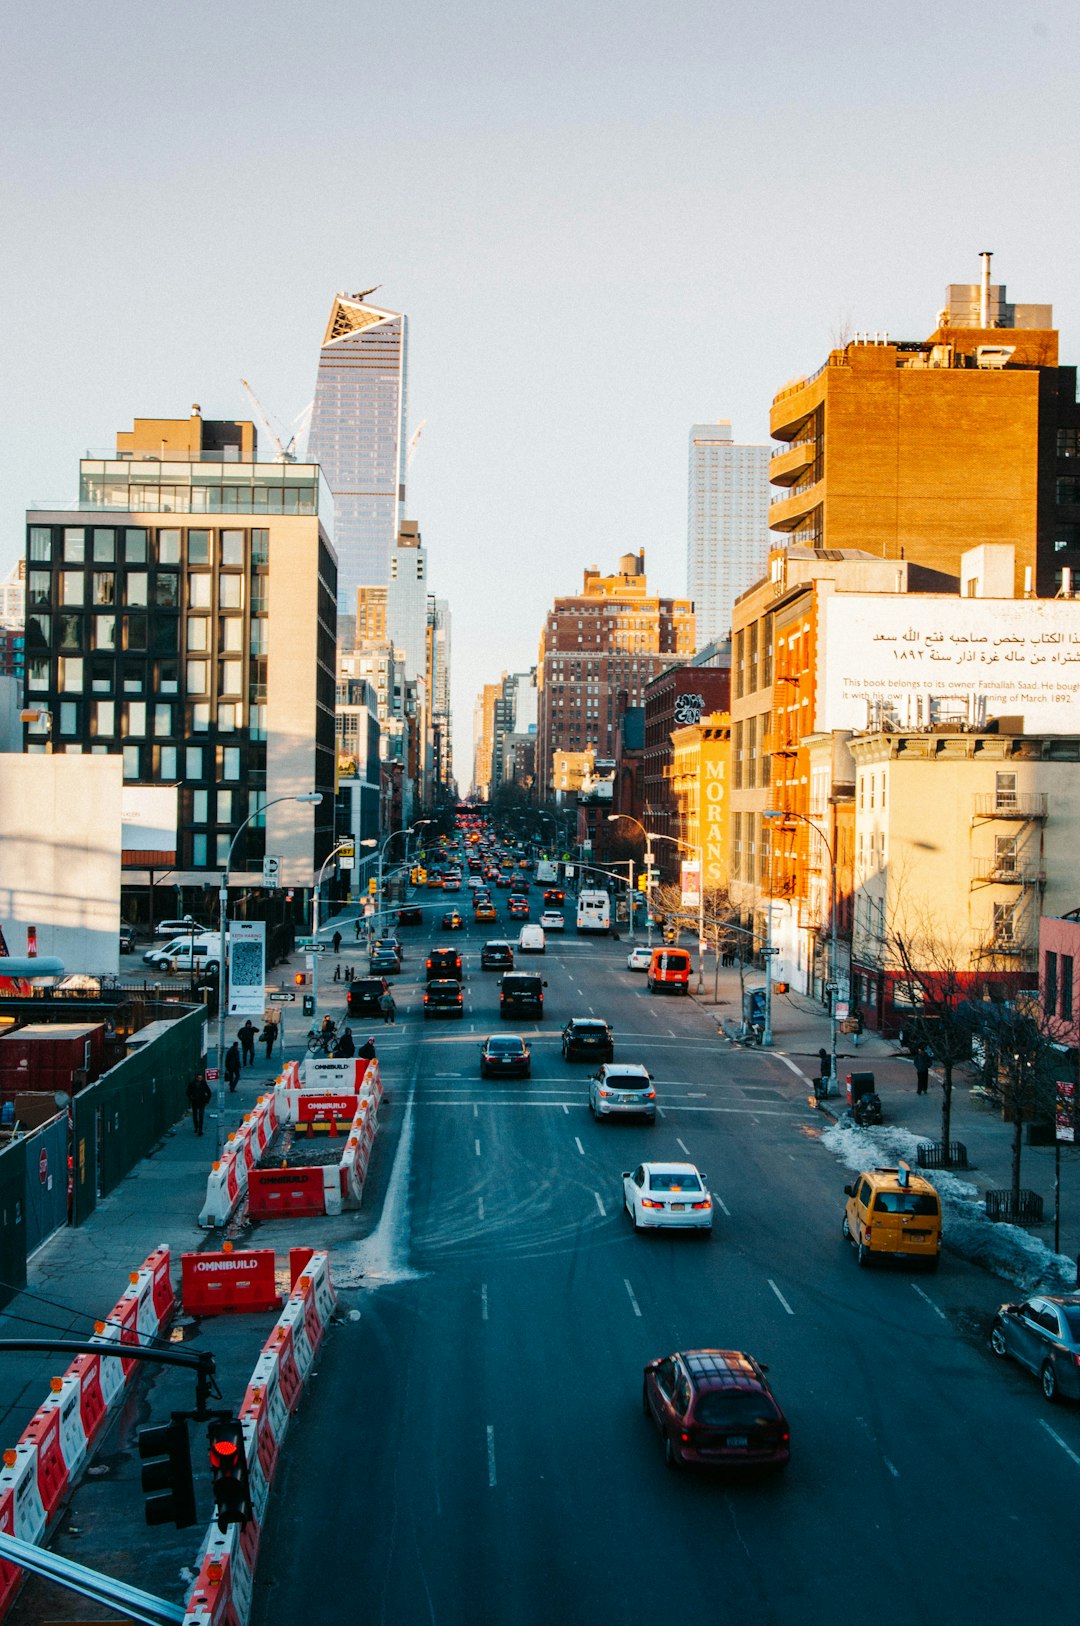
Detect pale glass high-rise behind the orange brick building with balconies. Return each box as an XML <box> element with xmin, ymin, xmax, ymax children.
<box><xmin>686</xmin><ymin>418</ymin><xmax>773</xmax><ymax>649</ymax></box>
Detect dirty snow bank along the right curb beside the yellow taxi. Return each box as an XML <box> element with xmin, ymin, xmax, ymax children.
<box><xmin>821</xmin><ymin>1124</ymin><xmax>1077</xmax><ymax>1293</ymax></box>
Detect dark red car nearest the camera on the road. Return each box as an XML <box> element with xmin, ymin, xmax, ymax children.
<box><xmin>641</xmin><ymin>1350</ymin><xmax>790</xmax><ymax>1468</ymax></box>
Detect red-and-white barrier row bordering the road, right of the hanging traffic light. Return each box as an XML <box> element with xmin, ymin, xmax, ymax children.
<box><xmin>184</xmin><ymin>1250</ymin><xmax>335</xmax><ymax>1626</ymax></box>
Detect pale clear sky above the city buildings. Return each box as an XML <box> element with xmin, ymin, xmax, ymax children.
<box><xmin>0</xmin><ymin>0</ymin><xmax>1080</xmax><ymax>784</ymax></box>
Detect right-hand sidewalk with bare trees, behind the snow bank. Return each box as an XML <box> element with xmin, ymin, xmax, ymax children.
<box><xmin>691</xmin><ymin>969</ymin><xmax>1080</xmax><ymax>1257</ymax></box>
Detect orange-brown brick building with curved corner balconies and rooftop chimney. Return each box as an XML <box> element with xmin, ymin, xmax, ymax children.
<box><xmin>769</xmin><ymin>254</ymin><xmax>1080</xmax><ymax>597</ymax></box>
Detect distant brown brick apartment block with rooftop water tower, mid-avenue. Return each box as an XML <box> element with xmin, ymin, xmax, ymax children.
<box><xmin>537</xmin><ymin>548</ymin><xmax>695</xmax><ymax>793</ymax></box>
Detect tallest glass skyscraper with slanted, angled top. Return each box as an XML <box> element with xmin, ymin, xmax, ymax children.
<box><xmin>307</xmin><ymin>288</ymin><xmax>408</xmax><ymax>616</ymax></box>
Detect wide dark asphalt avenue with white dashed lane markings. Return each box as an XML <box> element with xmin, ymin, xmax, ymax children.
<box><xmin>255</xmin><ymin>893</ymin><xmax>1080</xmax><ymax>1626</ymax></box>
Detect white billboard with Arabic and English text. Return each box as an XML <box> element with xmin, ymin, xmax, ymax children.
<box><xmin>817</xmin><ymin>593</ymin><xmax>1080</xmax><ymax>733</ymax></box>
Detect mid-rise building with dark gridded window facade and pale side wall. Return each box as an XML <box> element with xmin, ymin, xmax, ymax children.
<box><xmin>26</xmin><ymin>407</ymin><xmax>337</xmax><ymax>886</ymax></box>
